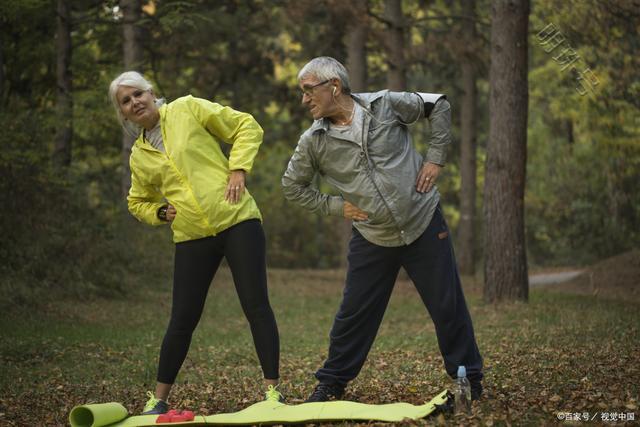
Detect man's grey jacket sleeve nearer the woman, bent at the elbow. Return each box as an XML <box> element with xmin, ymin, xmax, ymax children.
<box><xmin>282</xmin><ymin>136</ymin><xmax>344</xmax><ymax>216</ymax></box>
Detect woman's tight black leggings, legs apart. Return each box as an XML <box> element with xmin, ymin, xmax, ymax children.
<box><xmin>158</xmin><ymin>220</ymin><xmax>280</xmax><ymax>384</ymax></box>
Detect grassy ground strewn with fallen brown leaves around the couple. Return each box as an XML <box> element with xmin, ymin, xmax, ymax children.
<box><xmin>0</xmin><ymin>270</ymin><xmax>640</xmax><ymax>426</ymax></box>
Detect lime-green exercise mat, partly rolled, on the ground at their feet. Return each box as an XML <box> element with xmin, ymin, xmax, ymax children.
<box><xmin>69</xmin><ymin>390</ymin><xmax>447</xmax><ymax>427</ymax></box>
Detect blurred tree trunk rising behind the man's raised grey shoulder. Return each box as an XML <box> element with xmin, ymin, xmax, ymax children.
<box><xmin>384</xmin><ymin>0</ymin><xmax>407</xmax><ymax>91</ymax></box>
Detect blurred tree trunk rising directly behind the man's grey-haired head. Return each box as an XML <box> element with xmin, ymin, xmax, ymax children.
<box><xmin>340</xmin><ymin>0</ymin><xmax>369</xmax><ymax>267</ymax></box>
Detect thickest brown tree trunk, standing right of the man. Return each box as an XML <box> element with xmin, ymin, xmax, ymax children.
<box><xmin>484</xmin><ymin>0</ymin><xmax>529</xmax><ymax>302</ymax></box>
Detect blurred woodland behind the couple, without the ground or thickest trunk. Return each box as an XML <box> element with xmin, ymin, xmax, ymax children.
<box><xmin>0</xmin><ymin>0</ymin><xmax>640</xmax><ymax>305</ymax></box>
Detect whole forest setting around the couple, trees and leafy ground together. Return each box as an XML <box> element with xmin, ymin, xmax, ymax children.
<box><xmin>0</xmin><ymin>0</ymin><xmax>640</xmax><ymax>426</ymax></box>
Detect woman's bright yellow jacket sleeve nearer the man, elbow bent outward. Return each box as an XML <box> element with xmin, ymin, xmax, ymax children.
<box><xmin>189</xmin><ymin>97</ymin><xmax>264</xmax><ymax>173</ymax></box>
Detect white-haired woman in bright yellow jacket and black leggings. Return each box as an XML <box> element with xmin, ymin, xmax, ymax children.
<box><xmin>109</xmin><ymin>71</ymin><xmax>282</xmax><ymax>414</ymax></box>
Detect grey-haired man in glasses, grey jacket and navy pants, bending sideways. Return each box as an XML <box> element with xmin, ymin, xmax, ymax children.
<box><xmin>282</xmin><ymin>57</ymin><xmax>482</xmax><ymax>402</ymax></box>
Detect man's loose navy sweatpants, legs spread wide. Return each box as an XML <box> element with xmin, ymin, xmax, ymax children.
<box><xmin>316</xmin><ymin>206</ymin><xmax>482</xmax><ymax>386</ymax></box>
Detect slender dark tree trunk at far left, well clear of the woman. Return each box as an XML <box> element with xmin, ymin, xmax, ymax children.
<box><xmin>53</xmin><ymin>0</ymin><xmax>73</xmax><ymax>167</ymax></box>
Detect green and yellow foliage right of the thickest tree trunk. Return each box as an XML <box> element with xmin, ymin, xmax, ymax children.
<box><xmin>526</xmin><ymin>1</ymin><xmax>640</xmax><ymax>264</ymax></box>
